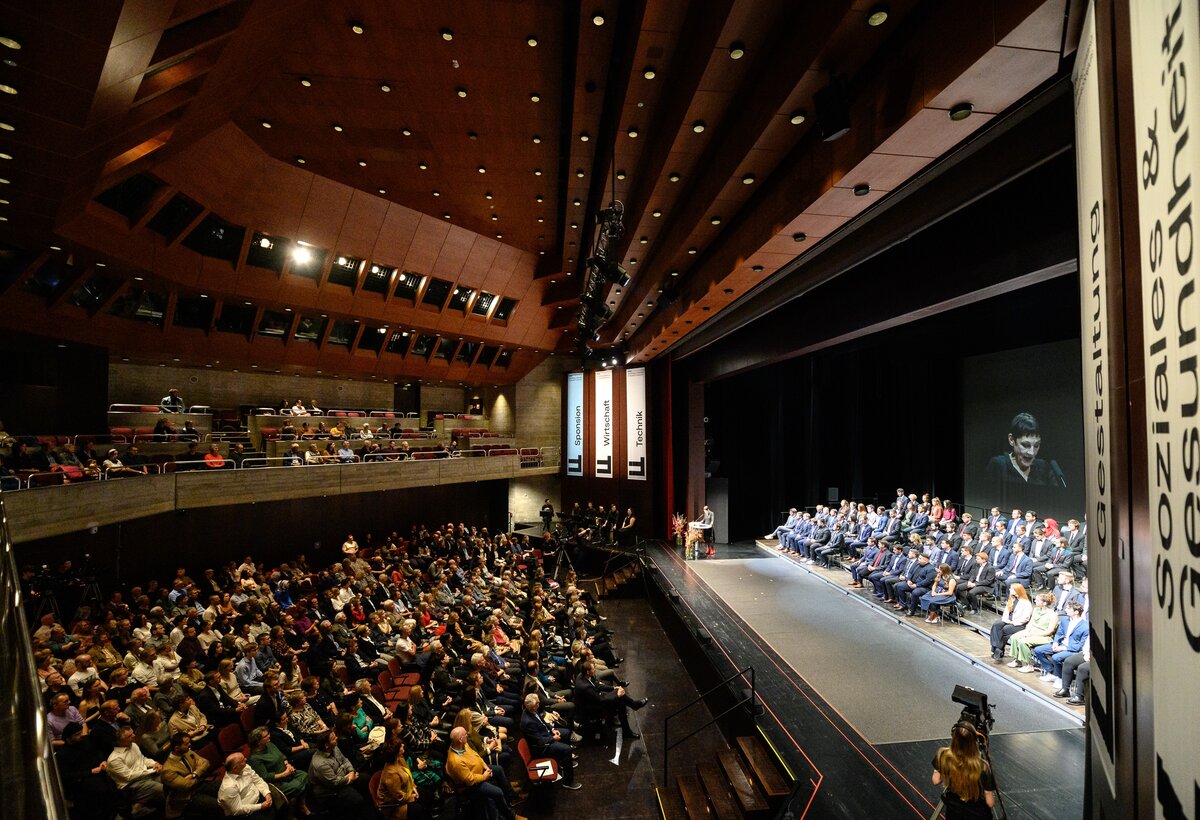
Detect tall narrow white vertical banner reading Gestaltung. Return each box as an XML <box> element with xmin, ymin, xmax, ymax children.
<box><xmin>1072</xmin><ymin>2</ymin><xmax>1117</xmax><ymax>797</ymax></box>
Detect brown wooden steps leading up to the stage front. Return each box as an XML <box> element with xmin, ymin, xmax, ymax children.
<box><xmin>659</xmin><ymin>736</ymin><xmax>791</xmax><ymax>820</ymax></box>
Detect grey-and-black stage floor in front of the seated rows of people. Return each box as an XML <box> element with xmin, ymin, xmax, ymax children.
<box><xmin>647</xmin><ymin>543</ymin><xmax>1085</xmax><ymax>820</ymax></box>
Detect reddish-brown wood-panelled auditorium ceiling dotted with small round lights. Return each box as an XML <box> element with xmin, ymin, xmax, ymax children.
<box><xmin>0</xmin><ymin>0</ymin><xmax>1079</xmax><ymax>384</ymax></box>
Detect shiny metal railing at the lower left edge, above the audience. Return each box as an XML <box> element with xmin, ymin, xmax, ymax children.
<box><xmin>0</xmin><ymin>493</ymin><xmax>67</xmax><ymax>820</ymax></box>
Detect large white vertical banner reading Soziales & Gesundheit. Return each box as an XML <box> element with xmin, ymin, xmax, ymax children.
<box><xmin>1129</xmin><ymin>0</ymin><xmax>1200</xmax><ymax>820</ymax></box>
